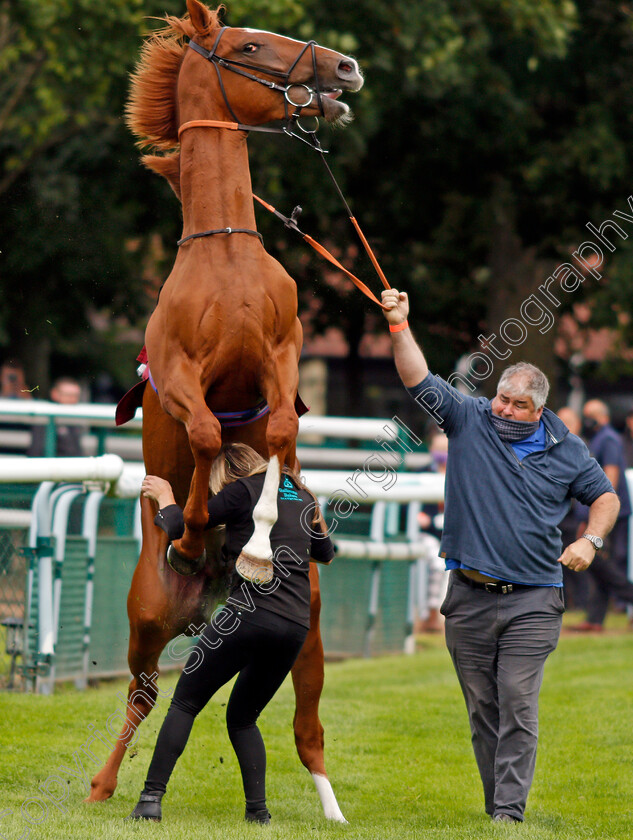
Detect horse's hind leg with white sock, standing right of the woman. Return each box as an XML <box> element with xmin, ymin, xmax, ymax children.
<box><xmin>292</xmin><ymin>564</ymin><xmax>347</xmax><ymax>822</ymax></box>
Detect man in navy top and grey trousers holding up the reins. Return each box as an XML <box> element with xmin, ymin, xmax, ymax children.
<box><xmin>382</xmin><ymin>289</ymin><xmax>620</xmax><ymax>822</ymax></box>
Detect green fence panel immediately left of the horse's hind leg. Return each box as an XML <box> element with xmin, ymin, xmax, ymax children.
<box><xmin>88</xmin><ymin>537</ymin><xmax>138</xmax><ymax>679</ymax></box>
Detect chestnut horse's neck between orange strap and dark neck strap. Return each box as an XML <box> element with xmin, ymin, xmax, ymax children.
<box><xmin>180</xmin><ymin>127</ymin><xmax>255</xmax><ymax>236</ymax></box>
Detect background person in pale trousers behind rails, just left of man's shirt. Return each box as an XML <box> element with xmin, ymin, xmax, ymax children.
<box><xmin>415</xmin><ymin>429</ymin><xmax>448</xmax><ymax>633</ymax></box>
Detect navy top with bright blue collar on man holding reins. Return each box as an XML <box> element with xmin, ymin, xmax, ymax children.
<box><xmin>408</xmin><ymin>373</ymin><xmax>614</xmax><ymax>586</ymax></box>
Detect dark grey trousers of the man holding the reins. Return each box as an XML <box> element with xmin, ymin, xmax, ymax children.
<box><xmin>441</xmin><ymin>572</ymin><xmax>565</xmax><ymax>820</ymax></box>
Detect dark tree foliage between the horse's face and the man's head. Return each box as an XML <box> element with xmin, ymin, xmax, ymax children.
<box><xmin>241</xmin><ymin>0</ymin><xmax>633</xmax><ymax>406</ymax></box>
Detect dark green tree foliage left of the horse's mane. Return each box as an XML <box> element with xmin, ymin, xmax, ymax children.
<box><xmin>0</xmin><ymin>0</ymin><xmax>185</xmax><ymax>388</ymax></box>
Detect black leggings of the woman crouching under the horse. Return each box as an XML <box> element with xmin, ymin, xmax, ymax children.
<box><xmin>143</xmin><ymin>610</ymin><xmax>308</xmax><ymax>811</ymax></box>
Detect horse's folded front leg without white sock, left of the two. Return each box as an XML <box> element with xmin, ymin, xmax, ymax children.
<box><xmin>165</xmin><ymin>386</ymin><xmax>222</xmax><ymax>574</ymax></box>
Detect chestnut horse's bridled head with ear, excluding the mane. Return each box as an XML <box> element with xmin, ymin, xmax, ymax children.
<box><xmin>179</xmin><ymin>0</ymin><xmax>363</xmax><ymax>125</ymax></box>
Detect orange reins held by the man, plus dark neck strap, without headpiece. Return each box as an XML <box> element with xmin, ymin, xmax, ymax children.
<box><xmin>178</xmin><ymin>120</ymin><xmax>391</xmax><ymax>309</ymax></box>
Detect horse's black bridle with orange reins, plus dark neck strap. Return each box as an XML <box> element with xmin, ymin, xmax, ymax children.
<box><xmin>177</xmin><ymin>26</ymin><xmax>391</xmax><ymax>309</ymax></box>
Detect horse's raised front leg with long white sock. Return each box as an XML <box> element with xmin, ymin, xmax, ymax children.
<box><xmin>235</xmin><ymin>343</ymin><xmax>299</xmax><ymax>583</ymax></box>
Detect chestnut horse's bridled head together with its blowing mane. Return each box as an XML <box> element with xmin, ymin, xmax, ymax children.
<box><xmin>126</xmin><ymin>0</ymin><xmax>363</xmax><ymax>189</ymax></box>
